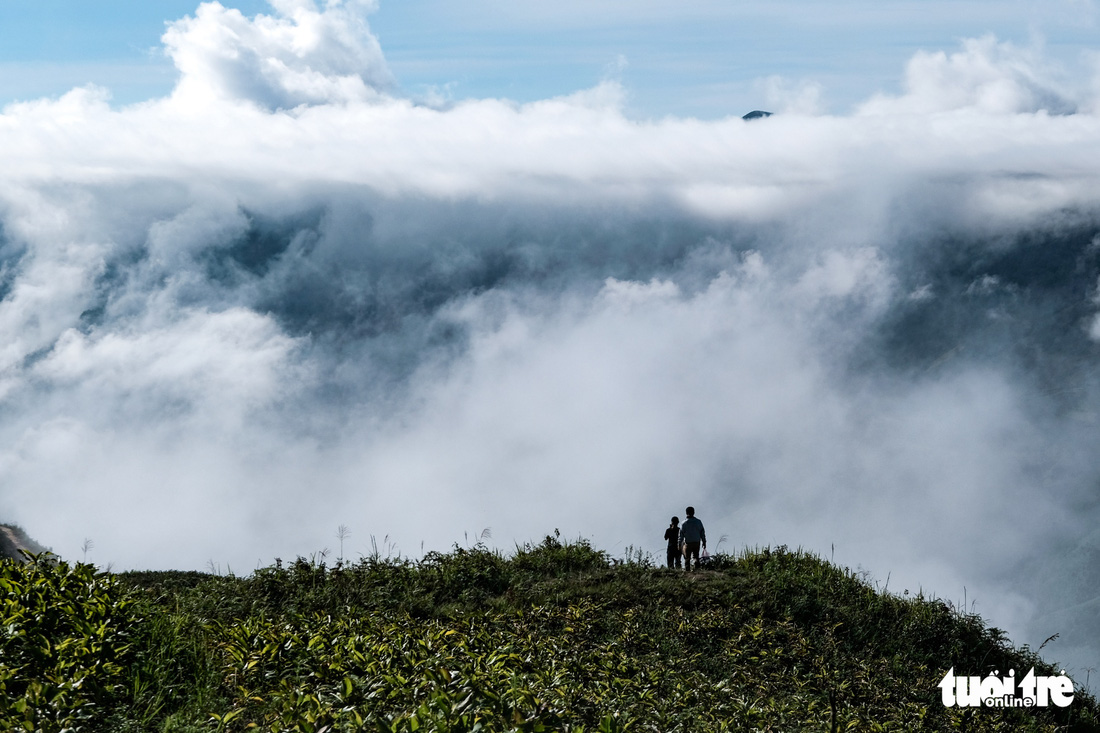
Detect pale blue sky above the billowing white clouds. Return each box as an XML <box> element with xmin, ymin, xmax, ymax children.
<box><xmin>0</xmin><ymin>0</ymin><xmax>1097</xmax><ymax>118</ymax></box>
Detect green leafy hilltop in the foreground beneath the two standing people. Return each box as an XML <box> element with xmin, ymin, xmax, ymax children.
<box><xmin>0</xmin><ymin>536</ymin><xmax>1100</xmax><ymax>733</ymax></box>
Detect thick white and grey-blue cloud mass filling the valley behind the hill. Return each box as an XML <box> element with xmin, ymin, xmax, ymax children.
<box><xmin>0</xmin><ymin>0</ymin><xmax>1100</xmax><ymax>667</ymax></box>
